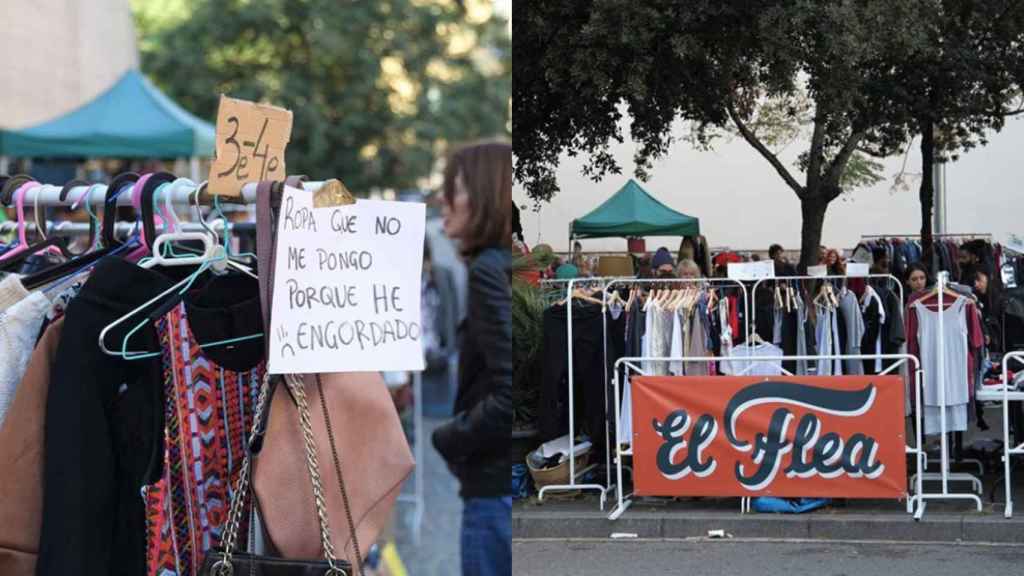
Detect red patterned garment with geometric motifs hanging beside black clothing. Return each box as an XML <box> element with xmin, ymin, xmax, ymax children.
<box><xmin>143</xmin><ymin>303</ymin><xmax>264</xmax><ymax>576</ymax></box>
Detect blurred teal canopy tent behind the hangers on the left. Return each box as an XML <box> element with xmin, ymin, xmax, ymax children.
<box><xmin>0</xmin><ymin>70</ymin><xmax>215</xmax><ymax>176</ymax></box>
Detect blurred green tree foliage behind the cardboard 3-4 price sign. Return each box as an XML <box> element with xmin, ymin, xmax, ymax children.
<box><xmin>133</xmin><ymin>0</ymin><xmax>512</xmax><ymax>192</ymax></box>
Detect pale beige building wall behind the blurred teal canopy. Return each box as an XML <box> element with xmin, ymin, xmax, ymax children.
<box><xmin>0</xmin><ymin>0</ymin><xmax>138</xmax><ymax>128</ymax></box>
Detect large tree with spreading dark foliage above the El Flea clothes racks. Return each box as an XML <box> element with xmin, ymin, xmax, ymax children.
<box><xmin>513</xmin><ymin>0</ymin><xmax>925</xmax><ymax>268</ymax></box>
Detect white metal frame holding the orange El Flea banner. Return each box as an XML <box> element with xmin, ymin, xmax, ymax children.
<box><xmin>608</xmin><ymin>354</ymin><xmax>925</xmax><ymax>520</ymax></box>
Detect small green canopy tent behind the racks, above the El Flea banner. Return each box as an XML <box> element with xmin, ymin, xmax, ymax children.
<box><xmin>569</xmin><ymin>179</ymin><xmax>700</xmax><ymax>240</ymax></box>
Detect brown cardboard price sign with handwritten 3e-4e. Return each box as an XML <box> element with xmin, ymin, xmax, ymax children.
<box><xmin>209</xmin><ymin>95</ymin><xmax>292</xmax><ymax>196</ymax></box>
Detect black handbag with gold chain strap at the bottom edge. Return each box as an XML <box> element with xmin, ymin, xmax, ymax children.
<box><xmin>199</xmin><ymin>374</ymin><xmax>362</xmax><ymax>576</ymax></box>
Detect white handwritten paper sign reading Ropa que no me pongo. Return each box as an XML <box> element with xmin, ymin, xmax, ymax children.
<box><xmin>268</xmin><ymin>187</ymin><xmax>426</xmax><ymax>374</ymax></box>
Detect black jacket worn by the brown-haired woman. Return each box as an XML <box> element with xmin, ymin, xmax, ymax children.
<box><xmin>433</xmin><ymin>243</ymin><xmax>513</xmax><ymax>498</ymax></box>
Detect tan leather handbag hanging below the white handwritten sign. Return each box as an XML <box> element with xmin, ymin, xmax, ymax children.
<box><xmin>253</xmin><ymin>182</ymin><xmax>415</xmax><ymax>566</ymax></box>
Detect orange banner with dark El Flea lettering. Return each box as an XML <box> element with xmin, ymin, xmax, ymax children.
<box><xmin>632</xmin><ymin>376</ymin><xmax>906</xmax><ymax>498</ymax></box>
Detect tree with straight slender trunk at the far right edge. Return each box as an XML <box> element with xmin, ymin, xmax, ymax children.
<box><xmin>866</xmin><ymin>0</ymin><xmax>1024</xmax><ymax>262</ymax></box>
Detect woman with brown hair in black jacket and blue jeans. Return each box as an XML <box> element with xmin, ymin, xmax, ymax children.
<box><xmin>433</xmin><ymin>141</ymin><xmax>513</xmax><ymax>576</ymax></box>
